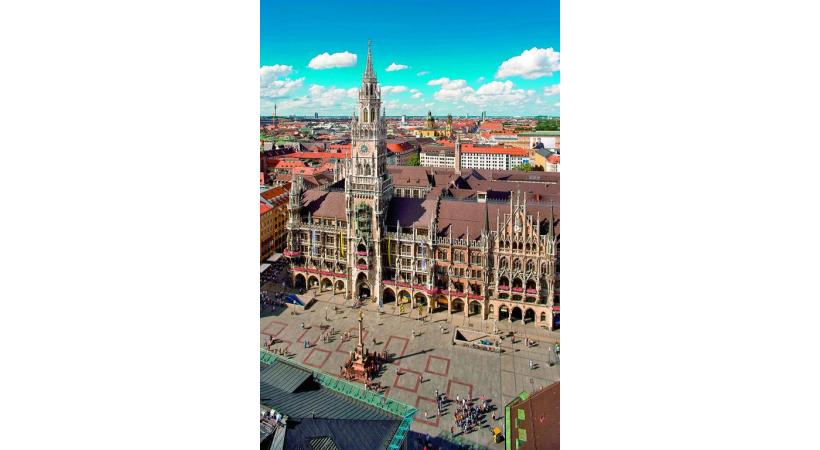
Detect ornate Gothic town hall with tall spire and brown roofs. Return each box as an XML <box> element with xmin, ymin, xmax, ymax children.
<box><xmin>284</xmin><ymin>42</ymin><xmax>560</xmax><ymax>329</ymax></box>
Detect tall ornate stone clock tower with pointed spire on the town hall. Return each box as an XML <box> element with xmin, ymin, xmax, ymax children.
<box><xmin>345</xmin><ymin>41</ymin><xmax>393</xmax><ymax>305</ymax></box>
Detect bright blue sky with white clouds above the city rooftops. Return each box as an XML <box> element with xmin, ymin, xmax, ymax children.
<box><xmin>260</xmin><ymin>0</ymin><xmax>560</xmax><ymax>116</ymax></box>
